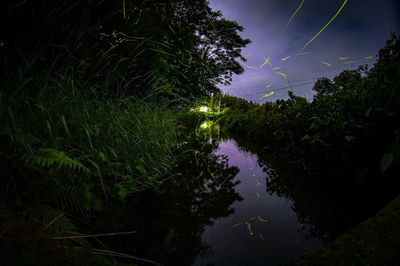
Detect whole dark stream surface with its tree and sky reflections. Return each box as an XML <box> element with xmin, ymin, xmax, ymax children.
<box><xmin>91</xmin><ymin>137</ymin><xmax>392</xmax><ymax>265</ymax></box>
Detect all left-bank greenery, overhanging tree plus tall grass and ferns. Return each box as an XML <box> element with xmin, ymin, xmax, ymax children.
<box><xmin>0</xmin><ymin>0</ymin><xmax>250</xmax><ymax>265</ymax></box>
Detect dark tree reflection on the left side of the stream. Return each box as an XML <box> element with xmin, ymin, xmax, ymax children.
<box><xmin>91</xmin><ymin>136</ymin><xmax>243</xmax><ymax>265</ymax></box>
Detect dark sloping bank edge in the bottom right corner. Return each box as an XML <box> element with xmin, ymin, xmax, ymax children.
<box><xmin>285</xmin><ymin>196</ymin><xmax>400</xmax><ymax>266</ymax></box>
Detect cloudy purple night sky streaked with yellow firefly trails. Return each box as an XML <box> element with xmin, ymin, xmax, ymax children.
<box><xmin>210</xmin><ymin>0</ymin><xmax>400</xmax><ymax>103</ymax></box>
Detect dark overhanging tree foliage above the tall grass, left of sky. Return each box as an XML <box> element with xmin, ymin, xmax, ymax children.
<box><xmin>0</xmin><ymin>0</ymin><xmax>250</xmax><ymax>107</ymax></box>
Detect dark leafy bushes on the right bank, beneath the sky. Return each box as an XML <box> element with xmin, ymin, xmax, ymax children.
<box><xmin>219</xmin><ymin>35</ymin><xmax>400</xmax><ymax>184</ymax></box>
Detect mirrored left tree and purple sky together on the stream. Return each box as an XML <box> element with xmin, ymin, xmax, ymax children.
<box><xmin>93</xmin><ymin>138</ymin><xmax>340</xmax><ymax>265</ymax></box>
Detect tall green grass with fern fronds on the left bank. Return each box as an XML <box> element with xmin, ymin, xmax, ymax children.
<box><xmin>0</xmin><ymin>59</ymin><xmax>178</xmax><ymax>235</ymax></box>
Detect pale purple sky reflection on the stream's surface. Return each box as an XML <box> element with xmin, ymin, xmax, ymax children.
<box><xmin>193</xmin><ymin>140</ymin><xmax>322</xmax><ymax>265</ymax></box>
